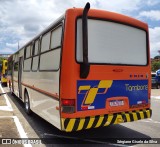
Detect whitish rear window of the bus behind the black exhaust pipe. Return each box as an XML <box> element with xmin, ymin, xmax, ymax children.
<box><xmin>76</xmin><ymin>18</ymin><xmax>147</xmax><ymax>65</ymax></box>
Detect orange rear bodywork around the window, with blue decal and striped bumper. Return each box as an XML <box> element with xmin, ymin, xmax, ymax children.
<box><xmin>60</xmin><ymin>9</ymin><xmax>152</xmax><ymax>132</ymax></box>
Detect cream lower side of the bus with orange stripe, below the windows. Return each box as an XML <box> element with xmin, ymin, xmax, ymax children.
<box><xmin>12</xmin><ymin>53</ymin><xmax>61</xmax><ymax>129</ymax></box>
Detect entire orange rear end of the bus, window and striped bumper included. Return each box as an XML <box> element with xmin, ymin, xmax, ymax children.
<box><xmin>60</xmin><ymin>3</ymin><xmax>151</xmax><ymax>132</ymax></box>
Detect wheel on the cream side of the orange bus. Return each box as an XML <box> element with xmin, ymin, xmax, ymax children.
<box><xmin>24</xmin><ymin>91</ymin><xmax>32</xmax><ymax>115</ymax></box>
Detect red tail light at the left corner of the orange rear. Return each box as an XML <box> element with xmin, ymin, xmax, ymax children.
<box><xmin>61</xmin><ymin>99</ymin><xmax>75</xmax><ymax>113</ymax></box>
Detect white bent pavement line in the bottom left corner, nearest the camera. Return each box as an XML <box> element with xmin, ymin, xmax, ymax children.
<box><xmin>0</xmin><ymin>116</ymin><xmax>32</xmax><ymax>147</ymax></box>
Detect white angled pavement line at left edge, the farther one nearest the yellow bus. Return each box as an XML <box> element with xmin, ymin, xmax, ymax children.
<box><xmin>0</xmin><ymin>84</ymin><xmax>13</xmax><ymax>111</ymax></box>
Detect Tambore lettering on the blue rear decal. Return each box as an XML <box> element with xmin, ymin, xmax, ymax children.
<box><xmin>125</xmin><ymin>84</ymin><xmax>148</xmax><ymax>91</ymax></box>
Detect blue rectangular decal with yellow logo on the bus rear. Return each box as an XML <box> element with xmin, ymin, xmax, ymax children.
<box><xmin>77</xmin><ymin>80</ymin><xmax>148</xmax><ymax>111</ymax></box>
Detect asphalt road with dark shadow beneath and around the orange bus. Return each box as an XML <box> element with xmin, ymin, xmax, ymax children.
<box><xmin>0</xmin><ymin>88</ymin><xmax>160</xmax><ymax>147</ymax></box>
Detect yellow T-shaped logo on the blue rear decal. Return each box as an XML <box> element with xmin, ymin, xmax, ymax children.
<box><xmin>78</xmin><ymin>80</ymin><xmax>113</xmax><ymax>110</ymax></box>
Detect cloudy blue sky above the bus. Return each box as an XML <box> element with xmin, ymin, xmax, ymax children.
<box><xmin>0</xmin><ymin>0</ymin><xmax>160</xmax><ymax>57</ymax></box>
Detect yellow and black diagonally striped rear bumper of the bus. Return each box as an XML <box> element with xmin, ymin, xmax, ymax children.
<box><xmin>62</xmin><ymin>109</ymin><xmax>152</xmax><ymax>132</ymax></box>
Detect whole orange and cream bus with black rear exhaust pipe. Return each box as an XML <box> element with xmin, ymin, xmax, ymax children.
<box><xmin>9</xmin><ymin>3</ymin><xmax>152</xmax><ymax>132</ymax></box>
